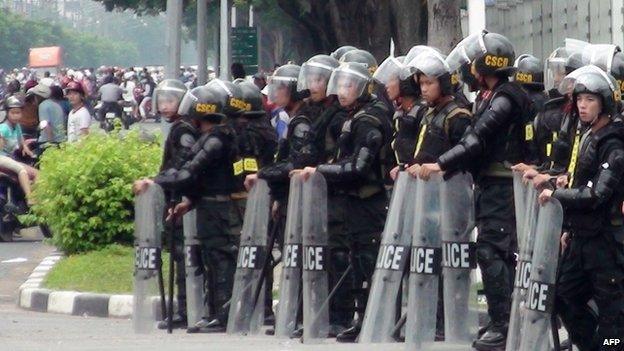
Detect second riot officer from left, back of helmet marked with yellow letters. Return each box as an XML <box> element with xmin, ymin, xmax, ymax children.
<box><xmin>154</xmin><ymin>86</ymin><xmax>237</xmax><ymax>333</ymax></box>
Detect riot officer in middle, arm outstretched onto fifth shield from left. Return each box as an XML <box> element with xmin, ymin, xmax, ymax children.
<box><xmin>302</xmin><ymin>62</ymin><xmax>391</xmax><ymax>342</ymax></box>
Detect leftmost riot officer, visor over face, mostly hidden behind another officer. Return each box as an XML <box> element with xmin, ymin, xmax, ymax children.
<box><xmin>134</xmin><ymin>79</ymin><xmax>198</xmax><ymax>329</ymax></box>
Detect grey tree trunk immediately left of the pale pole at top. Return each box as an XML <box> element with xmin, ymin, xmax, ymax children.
<box><xmin>427</xmin><ymin>0</ymin><xmax>462</xmax><ymax>53</ymax></box>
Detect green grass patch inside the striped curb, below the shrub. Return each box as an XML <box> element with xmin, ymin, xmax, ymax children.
<box><xmin>44</xmin><ymin>245</ymin><xmax>169</xmax><ymax>294</ymax></box>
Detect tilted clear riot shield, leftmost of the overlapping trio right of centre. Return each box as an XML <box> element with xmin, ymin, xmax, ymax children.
<box><xmin>358</xmin><ymin>172</ymin><xmax>416</xmax><ymax>343</ymax></box>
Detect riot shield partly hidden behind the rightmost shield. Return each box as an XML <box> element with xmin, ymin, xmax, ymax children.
<box><xmin>507</xmin><ymin>184</ymin><xmax>539</xmax><ymax>350</ymax></box>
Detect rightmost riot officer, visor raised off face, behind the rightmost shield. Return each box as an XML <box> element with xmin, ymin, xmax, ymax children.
<box><xmin>539</xmin><ymin>66</ymin><xmax>624</xmax><ymax>351</ymax></box>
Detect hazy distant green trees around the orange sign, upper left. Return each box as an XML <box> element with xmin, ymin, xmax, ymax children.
<box><xmin>0</xmin><ymin>9</ymin><xmax>139</xmax><ymax>68</ymax></box>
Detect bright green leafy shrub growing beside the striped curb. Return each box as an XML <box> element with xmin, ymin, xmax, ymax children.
<box><xmin>26</xmin><ymin>131</ymin><xmax>162</xmax><ymax>254</ymax></box>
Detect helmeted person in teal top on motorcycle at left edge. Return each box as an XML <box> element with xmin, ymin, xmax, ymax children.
<box><xmin>0</xmin><ymin>96</ymin><xmax>37</xmax><ymax>205</ymax></box>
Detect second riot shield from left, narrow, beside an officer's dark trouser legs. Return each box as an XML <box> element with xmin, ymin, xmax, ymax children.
<box><xmin>183</xmin><ymin>210</ymin><xmax>206</xmax><ymax>326</ymax></box>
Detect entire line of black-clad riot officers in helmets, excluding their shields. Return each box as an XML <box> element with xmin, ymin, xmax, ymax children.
<box><xmin>134</xmin><ymin>31</ymin><xmax>624</xmax><ymax>350</ymax></box>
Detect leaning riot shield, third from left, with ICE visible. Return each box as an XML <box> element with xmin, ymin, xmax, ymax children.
<box><xmin>227</xmin><ymin>179</ymin><xmax>271</xmax><ymax>335</ymax></box>
